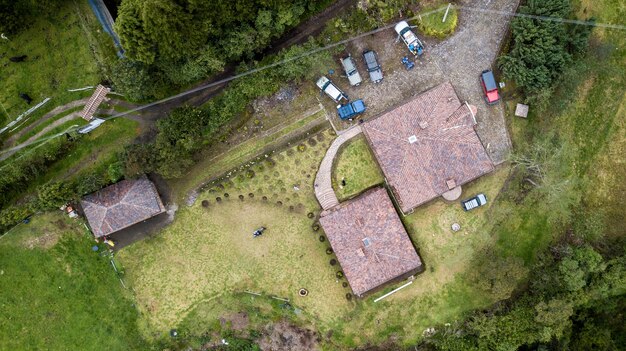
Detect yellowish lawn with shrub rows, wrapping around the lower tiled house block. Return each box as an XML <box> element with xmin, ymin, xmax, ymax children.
<box><xmin>119</xmin><ymin>126</ymin><xmax>508</xmax><ymax>347</ymax></box>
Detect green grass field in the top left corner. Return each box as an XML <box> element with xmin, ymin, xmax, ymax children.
<box><xmin>0</xmin><ymin>1</ymin><xmax>115</xmax><ymax>132</ymax></box>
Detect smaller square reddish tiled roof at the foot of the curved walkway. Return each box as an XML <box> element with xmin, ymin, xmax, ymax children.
<box><xmin>320</xmin><ymin>188</ymin><xmax>422</xmax><ymax>296</ymax></box>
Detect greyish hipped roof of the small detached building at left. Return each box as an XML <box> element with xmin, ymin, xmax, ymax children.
<box><xmin>81</xmin><ymin>176</ymin><xmax>165</xmax><ymax>237</ymax></box>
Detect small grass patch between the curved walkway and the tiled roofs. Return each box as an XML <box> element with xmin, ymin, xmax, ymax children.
<box><xmin>333</xmin><ymin>136</ymin><xmax>383</xmax><ymax>201</ymax></box>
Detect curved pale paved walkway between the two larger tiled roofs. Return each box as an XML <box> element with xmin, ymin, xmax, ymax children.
<box><xmin>315</xmin><ymin>125</ymin><xmax>362</xmax><ymax>210</ymax></box>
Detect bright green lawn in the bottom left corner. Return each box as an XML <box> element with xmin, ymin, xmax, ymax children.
<box><xmin>0</xmin><ymin>211</ymin><xmax>142</xmax><ymax>350</ymax></box>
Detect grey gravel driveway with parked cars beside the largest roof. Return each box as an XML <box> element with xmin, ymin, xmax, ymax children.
<box><xmin>322</xmin><ymin>0</ymin><xmax>519</xmax><ymax>164</ymax></box>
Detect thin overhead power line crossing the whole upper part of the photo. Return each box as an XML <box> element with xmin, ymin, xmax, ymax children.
<box><xmin>0</xmin><ymin>5</ymin><xmax>626</xmax><ymax>155</ymax></box>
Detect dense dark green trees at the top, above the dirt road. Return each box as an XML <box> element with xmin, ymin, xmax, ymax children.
<box><xmin>113</xmin><ymin>0</ymin><xmax>329</xmax><ymax>100</ymax></box>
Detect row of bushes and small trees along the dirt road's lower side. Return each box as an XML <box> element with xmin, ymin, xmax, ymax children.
<box><xmin>118</xmin><ymin>42</ymin><xmax>331</xmax><ymax>179</ymax></box>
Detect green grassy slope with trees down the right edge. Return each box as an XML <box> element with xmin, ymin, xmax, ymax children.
<box><xmin>420</xmin><ymin>1</ymin><xmax>626</xmax><ymax>350</ymax></box>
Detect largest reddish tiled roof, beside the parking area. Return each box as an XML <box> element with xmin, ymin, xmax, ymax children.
<box><xmin>363</xmin><ymin>83</ymin><xmax>493</xmax><ymax>213</ymax></box>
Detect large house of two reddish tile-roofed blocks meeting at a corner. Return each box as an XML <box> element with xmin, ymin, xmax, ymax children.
<box><xmin>320</xmin><ymin>83</ymin><xmax>494</xmax><ymax>296</ymax></box>
